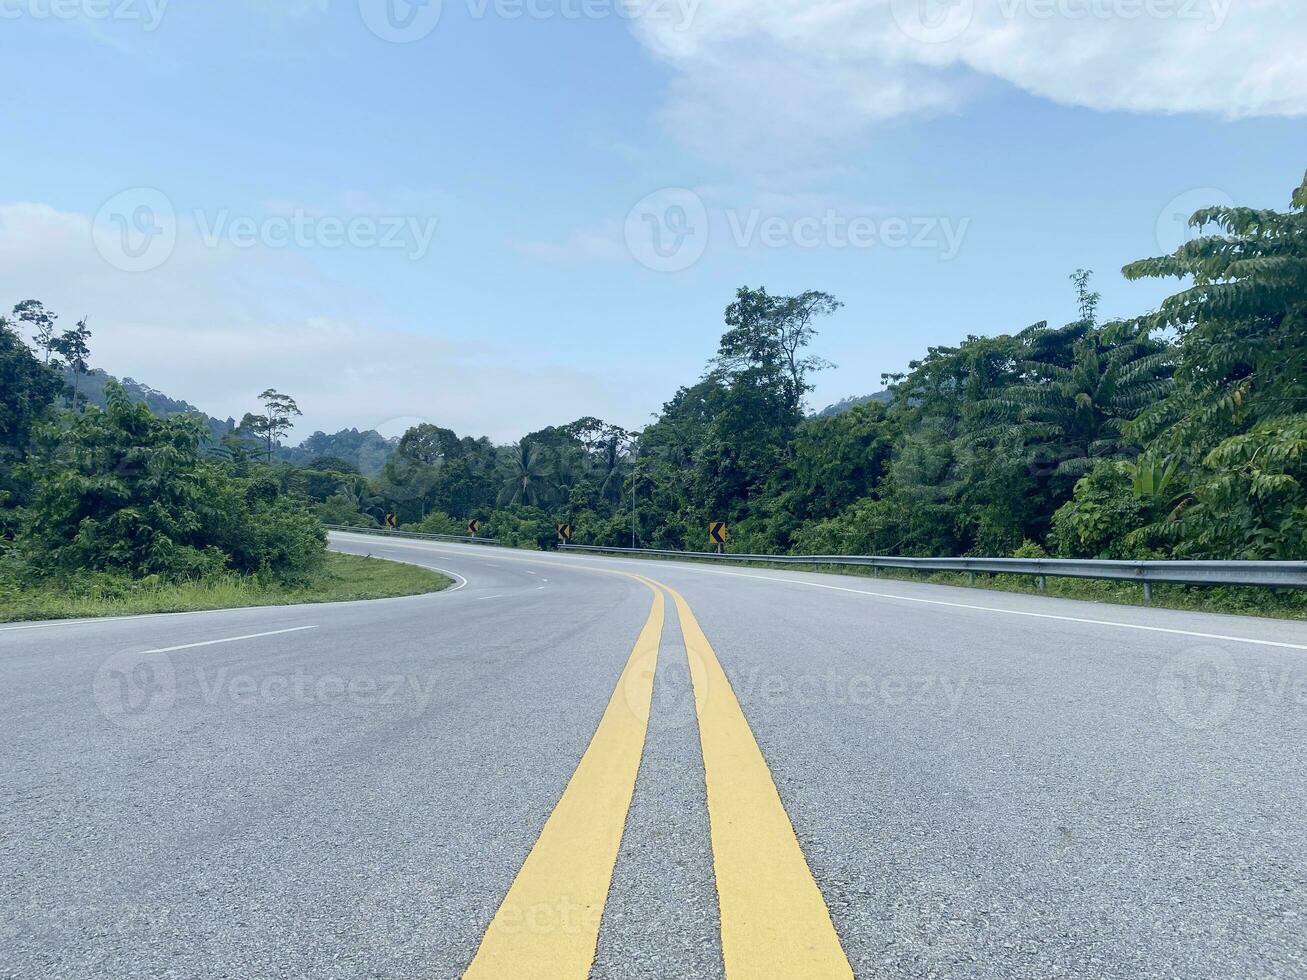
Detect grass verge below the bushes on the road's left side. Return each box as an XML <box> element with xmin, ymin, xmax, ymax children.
<box><xmin>0</xmin><ymin>553</ymin><xmax>454</xmax><ymax>622</ymax></box>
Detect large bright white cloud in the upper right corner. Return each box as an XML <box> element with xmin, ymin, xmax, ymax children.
<box><xmin>633</xmin><ymin>0</ymin><xmax>1307</xmax><ymax>153</ymax></box>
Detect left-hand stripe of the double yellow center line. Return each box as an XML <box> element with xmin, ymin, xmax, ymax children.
<box><xmin>464</xmin><ymin>576</ymin><xmax>664</xmax><ymax>980</ymax></box>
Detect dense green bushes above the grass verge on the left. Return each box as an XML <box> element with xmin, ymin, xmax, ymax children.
<box><xmin>0</xmin><ymin>321</ymin><xmax>325</xmax><ymax>588</ymax></box>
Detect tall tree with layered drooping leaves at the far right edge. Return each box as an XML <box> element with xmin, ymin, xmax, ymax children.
<box><xmin>1124</xmin><ymin>176</ymin><xmax>1307</xmax><ymax>558</ymax></box>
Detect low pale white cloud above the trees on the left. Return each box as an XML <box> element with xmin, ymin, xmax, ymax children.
<box><xmin>0</xmin><ymin>204</ymin><xmax>656</xmax><ymax>442</ymax></box>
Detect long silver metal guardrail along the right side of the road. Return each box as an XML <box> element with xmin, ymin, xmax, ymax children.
<box><xmin>561</xmin><ymin>545</ymin><xmax>1307</xmax><ymax>598</ymax></box>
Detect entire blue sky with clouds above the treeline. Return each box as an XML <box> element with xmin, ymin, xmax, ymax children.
<box><xmin>0</xmin><ymin>0</ymin><xmax>1307</xmax><ymax>440</ymax></box>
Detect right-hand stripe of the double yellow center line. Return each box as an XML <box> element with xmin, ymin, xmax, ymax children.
<box><xmin>660</xmin><ymin>583</ymin><xmax>853</xmax><ymax>980</ymax></box>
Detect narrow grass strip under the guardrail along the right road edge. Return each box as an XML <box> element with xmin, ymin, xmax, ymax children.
<box><xmin>572</xmin><ymin>555</ymin><xmax>1307</xmax><ymax>619</ymax></box>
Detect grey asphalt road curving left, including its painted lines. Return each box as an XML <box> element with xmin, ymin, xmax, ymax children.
<box><xmin>0</xmin><ymin>536</ymin><xmax>1307</xmax><ymax>980</ymax></box>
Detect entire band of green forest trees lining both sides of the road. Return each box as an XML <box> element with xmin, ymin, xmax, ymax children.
<box><xmin>0</xmin><ymin>172</ymin><xmax>1307</xmax><ymax>611</ymax></box>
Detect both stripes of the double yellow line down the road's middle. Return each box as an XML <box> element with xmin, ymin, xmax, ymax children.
<box><xmin>464</xmin><ymin>568</ymin><xmax>853</xmax><ymax>980</ymax></box>
